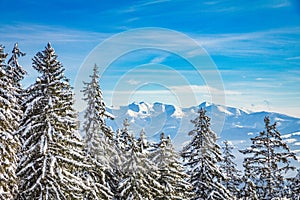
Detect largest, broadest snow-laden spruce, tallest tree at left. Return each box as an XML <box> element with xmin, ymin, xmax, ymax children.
<box><xmin>17</xmin><ymin>43</ymin><xmax>90</xmax><ymax>200</ymax></box>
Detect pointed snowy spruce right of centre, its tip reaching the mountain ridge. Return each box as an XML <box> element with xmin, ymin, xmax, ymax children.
<box><xmin>181</xmin><ymin>108</ymin><xmax>231</xmax><ymax>200</ymax></box>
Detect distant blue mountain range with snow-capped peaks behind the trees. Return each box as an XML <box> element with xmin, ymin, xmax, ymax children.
<box><xmin>80</xmin><ymin>102</ymin><xmax>300</xmax><ymax>163</ymax></box>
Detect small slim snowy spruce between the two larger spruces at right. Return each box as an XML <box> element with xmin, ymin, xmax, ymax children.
<box><xmin>220</xmin><ymin>140</ymin><xmax>241</xmax><ymax>197</ymax></box>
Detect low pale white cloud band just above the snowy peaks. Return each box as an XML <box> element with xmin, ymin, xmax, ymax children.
<box><xmin>104</xmin><ymin>85</ymin><xmax>240</xmax><ymax>107</ymax></box>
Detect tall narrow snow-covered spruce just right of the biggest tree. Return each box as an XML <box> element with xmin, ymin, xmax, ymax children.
<box><xmin>83</xmin><ymin>64</ymin><xmax>117</xmax><ymax>199</ymax></box>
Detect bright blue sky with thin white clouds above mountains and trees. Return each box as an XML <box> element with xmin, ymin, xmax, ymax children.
<box><xmin>0</xmin><ymin>0</ymin><xmax>300</xmax><ymax>117</ymax></box>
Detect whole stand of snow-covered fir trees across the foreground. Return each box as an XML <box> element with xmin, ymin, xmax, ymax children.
<box><xmin>0</xmin><ymin>43</ymin><xmax>300</xmax><ymax>200</ymax></box>
